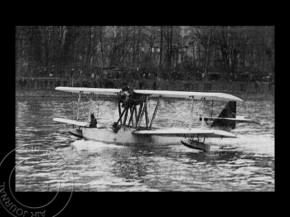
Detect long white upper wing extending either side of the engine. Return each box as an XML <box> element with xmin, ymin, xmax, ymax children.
<box><xmin>55</xmin><ymin>87</ymin><xmax>243</xmax><ymax>101</ymax></box>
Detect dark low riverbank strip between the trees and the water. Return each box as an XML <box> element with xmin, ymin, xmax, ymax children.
<box><xmin>16</xmin><ymin>78</ymin><xmax>275</xmax><ymax>95</ymax></box>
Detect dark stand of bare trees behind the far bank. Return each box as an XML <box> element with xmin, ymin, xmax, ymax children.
<box><xmin>15</xmin><ymin>26</ymin><xmax>275</xmax><ymax>82</ymax></box>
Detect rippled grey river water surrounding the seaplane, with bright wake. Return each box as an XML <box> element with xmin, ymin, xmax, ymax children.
<box><xmin>16</xmin><ymin>92</ymin><xmax>275</xmax><ymax>191</ymax></box>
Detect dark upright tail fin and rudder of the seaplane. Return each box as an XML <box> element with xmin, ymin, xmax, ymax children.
<box><xmin>211</xmin><ymin>101</ymin><xmax>237</xmax><ymax>129</ymax></box>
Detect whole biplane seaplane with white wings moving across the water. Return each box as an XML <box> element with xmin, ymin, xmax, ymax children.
<box><xmin>53</xmin><ymin>86</ymin><xmax>258</xmax><ymax>152</ymax></box>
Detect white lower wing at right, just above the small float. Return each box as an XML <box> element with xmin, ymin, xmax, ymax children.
<box><xmin>132</xmin><ymin>128</ymin><xmax>236</xmax><ymax>138</ymax></box>
